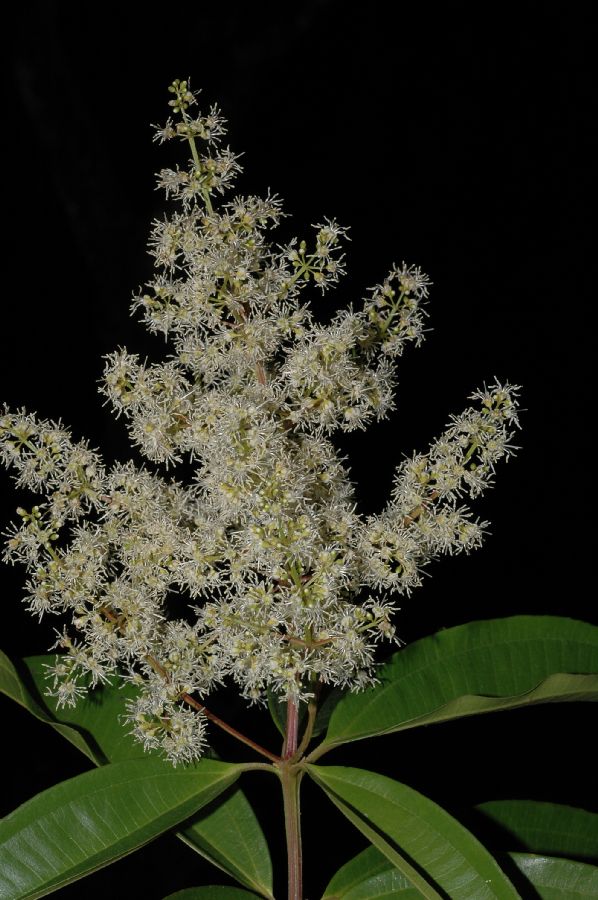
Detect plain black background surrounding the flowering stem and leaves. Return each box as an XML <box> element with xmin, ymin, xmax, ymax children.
<box><xmin>0</xmin><ymin>0</ymin><xmax>598</xmax><ymax>900</ymax></box>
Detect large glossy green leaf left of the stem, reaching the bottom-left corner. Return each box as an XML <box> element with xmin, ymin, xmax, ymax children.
<box><xmin>0</xmin><ymin>759</ymin><xmax>243</xmax><ymax>900</ymax></box>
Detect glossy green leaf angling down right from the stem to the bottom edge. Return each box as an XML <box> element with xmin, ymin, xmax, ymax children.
<box><xmin>306</xmin><ymin>765</ymin><xmax>519</xmax><ymax>900</ymax></box>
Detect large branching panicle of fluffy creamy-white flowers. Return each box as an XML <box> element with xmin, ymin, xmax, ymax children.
<box><xmin>0</xmin><ymin>81</ymin><xmax>517</xmax><ymax>762</ymax></box>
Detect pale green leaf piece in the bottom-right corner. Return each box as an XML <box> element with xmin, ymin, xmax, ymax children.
<box><xmin>510</xmin><ymin>853</ymin><xmax>598</xmax><ymax>900</ymax></box>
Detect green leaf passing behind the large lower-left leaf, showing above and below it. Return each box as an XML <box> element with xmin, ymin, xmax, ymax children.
<box><xmin>15</xmin><ymin>656</ymin><xmax>273</xmax><ymax>898</ymax></box>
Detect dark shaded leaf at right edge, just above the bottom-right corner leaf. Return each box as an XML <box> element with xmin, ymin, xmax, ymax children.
<box><xmin>476</xmin><ymin>800</ymin><xmax>598</xmax><ymax>862</ymax></box>
